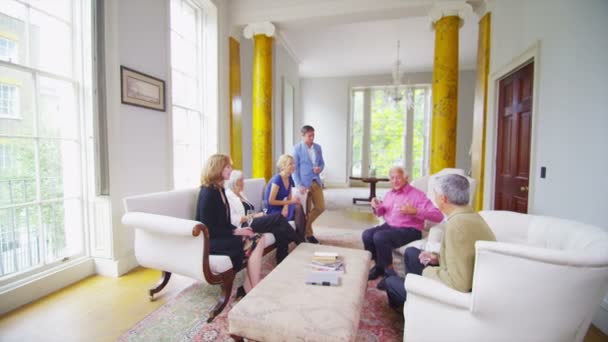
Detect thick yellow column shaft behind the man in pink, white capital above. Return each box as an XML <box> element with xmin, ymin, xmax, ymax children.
<box><xmin>430</xmin><ymin>15</ymin><xmax>460</xmax><ymax>173</ymax></box>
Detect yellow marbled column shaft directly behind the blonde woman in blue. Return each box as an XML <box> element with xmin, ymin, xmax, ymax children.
<box><xmin>251</xmin><ymin>34</ymin><xmax>273</xmax><ymax>181</ymax></box>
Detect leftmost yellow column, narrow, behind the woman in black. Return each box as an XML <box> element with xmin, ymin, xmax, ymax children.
<box><xmin>229</xmin><ymin>37</ymin><xmax>243</xmax><ymax>170</ymax></box>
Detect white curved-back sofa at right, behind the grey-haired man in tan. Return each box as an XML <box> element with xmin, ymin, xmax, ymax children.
<box><xmin>403</xmin><ymin>211</ymin><xmax>608</xmax><ymax>342</ymax></box>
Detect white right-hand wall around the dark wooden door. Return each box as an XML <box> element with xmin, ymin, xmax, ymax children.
<box><xmin>484</xmin><ymin>0</ymin><xmax>608</xmax><ymax>333</ymax></box>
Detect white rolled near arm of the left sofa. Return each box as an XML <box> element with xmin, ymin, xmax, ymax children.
<box><xmin>122</xmin><ymin>212</ymin><xmax>203</xmax><ymax>236</ymax></box>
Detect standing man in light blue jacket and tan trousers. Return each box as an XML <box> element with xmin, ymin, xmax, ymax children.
<box><xmin>293</xmin><ymin>125</ymin><xmax>325</xmax><ymax>243</ymax></box>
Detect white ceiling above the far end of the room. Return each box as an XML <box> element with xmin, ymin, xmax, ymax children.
<box><xmin>230</xmin><ymin>0</ymin><xmax>478</xmax><ymax>78</ymax></box>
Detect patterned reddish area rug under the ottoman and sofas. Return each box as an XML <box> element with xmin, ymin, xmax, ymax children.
<box><xmin>118</xmin><ymin>212</ymin><xmax>403</xmax><ymax>342</ymax></box>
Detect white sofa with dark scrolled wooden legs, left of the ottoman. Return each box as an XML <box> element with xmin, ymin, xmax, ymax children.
<box><xmin>122</xmin><ymin>178</ymin><xmax>275</xmax><ymax>322</ymax></box>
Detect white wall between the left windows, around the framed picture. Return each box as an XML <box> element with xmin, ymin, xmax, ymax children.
<box><xmin>106</xmin><ymin>0</ymin><xmax>172</xmax><ymax>260</ymax></box>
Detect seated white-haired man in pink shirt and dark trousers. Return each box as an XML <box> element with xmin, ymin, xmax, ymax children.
<box><xmin>363</xmin><ymin>166</ymin><xmax>443</xmax><ymax>280</ymax></box>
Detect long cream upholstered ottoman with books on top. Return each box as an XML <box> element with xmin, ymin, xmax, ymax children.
<box><xmin>228</xmin><ymin>243</ymin><xmax>371</xmax><ymax>341</ymax></box>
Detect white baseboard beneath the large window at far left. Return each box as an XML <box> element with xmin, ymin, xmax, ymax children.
<box><xmin>0</xmin><ymin>257</ymin><xmax>95</xmax><ymax>315</ymax></box>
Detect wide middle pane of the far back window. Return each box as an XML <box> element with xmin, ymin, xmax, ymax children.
<box><xmin>370</xmin><ymin>89</ymin><xmax>405</xmax><ymax>177</ymax></box>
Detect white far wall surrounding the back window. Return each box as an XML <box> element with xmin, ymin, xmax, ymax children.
<box><xmin>300</xmin><ymin>71</ymin><xmax>475</xmax><ymax>186</ymax></box>
